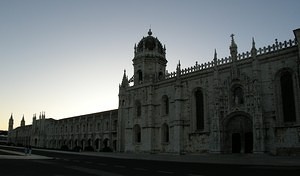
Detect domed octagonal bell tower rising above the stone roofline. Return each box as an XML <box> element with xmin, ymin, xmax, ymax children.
<box><xmin>132</xmin><ymin>29</ymin><xmax>168</xmax><ymax>85</ymax></box>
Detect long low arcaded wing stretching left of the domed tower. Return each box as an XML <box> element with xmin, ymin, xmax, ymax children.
<box><xmin>8</xmin><ymin>110</ymin><xmax>118</xmax><ymax>151</ymax></box>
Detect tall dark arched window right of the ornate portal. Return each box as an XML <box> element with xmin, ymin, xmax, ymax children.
<box><xmin>280</xmin><ymin>71</ymin><xmax>296</xmax><ymax>122</ymax></box>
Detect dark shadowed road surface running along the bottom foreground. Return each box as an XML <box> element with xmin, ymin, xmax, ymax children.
<box><xmin>0</xmin><ymin>146</ymin><xmax>300</xmax><ymax>176</ymax></box>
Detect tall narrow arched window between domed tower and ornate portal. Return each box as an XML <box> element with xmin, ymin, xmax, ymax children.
<box><xmin>194</xmin><ymin>89</ymin><xmax>204</xmax><ymax>130</ymax></box>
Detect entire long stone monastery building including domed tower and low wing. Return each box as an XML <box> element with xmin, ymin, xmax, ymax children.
<box><xmin>8</xmin><ymin>29</ymin><xmax>300</xmax><ymax>154</ymax></box>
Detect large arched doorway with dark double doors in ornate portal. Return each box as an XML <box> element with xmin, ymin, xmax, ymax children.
<box><xmin>221</xmin><ymin>111</ymin><xmax>253</xmax><ymax>153</ymax></box>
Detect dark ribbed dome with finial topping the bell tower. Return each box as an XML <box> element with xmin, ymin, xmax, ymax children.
<box><xmin>135</xmin><ymin>29</ymin><xmax>166</xmax><ymax>58</ymax></box>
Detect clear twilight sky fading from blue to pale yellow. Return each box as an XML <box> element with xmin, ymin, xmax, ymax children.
<box><xmin>0</xmin><ymin>0</ymin><xmax>300</xmax><ymax>130</ymax></box>
